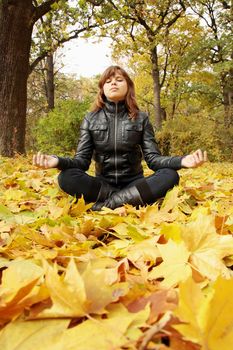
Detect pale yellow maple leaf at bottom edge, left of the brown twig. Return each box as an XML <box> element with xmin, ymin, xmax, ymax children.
<box><xmin>61</xmin><ymin>303</ymin><xmax>150</xmax><ymax>350</ymax></box>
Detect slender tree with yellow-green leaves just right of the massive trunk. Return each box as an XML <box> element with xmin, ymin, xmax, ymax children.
<box><xmin>30</xmin><ymin>1</ymin><xmax>101</xmax><ymax>110</ymax></box>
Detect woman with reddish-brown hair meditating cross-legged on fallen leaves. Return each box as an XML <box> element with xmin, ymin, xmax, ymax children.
<box><xmin>33</xmin><ymin>66</ymin><xmax>207</xmax><ymax>210</ymax></box>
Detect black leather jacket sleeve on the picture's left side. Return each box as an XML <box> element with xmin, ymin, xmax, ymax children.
<box><xmin>58</xmin><ymin>117</ymin><xmax>93</xmax><ymax>171</ymax></box>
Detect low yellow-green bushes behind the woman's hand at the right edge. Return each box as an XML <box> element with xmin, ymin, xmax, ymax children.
<box><xmin>156</xmin><ymin>112</ymin><xmax>233</xmax><ymax>161</ymax></box>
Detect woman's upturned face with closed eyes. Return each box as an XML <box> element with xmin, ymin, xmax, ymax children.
<box><xmin>103</xmin><ymin>73</ymin><xmax>128</xmax><ymax>102</ymax></box>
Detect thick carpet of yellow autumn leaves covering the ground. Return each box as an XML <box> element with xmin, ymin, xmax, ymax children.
<box><xmin>0</xmin><ymin>158</ymin><xmax>233</xmax><ymax>350</ymax></box>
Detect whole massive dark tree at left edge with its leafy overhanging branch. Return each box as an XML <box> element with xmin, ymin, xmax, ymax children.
<box><xmin>0</xmin><ymin>0</ymin><xmax>110</xmax><ymax>157</ymax></box>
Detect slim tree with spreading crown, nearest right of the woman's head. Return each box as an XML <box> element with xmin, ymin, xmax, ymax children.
<box><xmin>101</xmin><ymin>0</ymin><xmax>185</xmax><ymax>128</ymax></box>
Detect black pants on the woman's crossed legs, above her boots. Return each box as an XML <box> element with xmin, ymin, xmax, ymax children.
<box><xmin>58</xmin><ymin>168</ymin><xmax>179</xmax><ymax>204</ymax></box>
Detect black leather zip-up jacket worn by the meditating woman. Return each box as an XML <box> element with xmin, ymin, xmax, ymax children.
<box><xmin>58</xmin><ymin>101</ymin><xmax>182</xmax><ymax>185</ymax></box>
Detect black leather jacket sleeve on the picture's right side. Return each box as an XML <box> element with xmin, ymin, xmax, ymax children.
<box><xmin>142</xmin><ymin>116</ymin><xmax>183</xmax><ymax>171</ymax></box>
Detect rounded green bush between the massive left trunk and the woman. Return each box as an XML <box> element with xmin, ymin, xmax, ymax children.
<box><xmin>35</xmin><ymin>99</ymin><xmax>90</xmax><ymax>154</ymax></box>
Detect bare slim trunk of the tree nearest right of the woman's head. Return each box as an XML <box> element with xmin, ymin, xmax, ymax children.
<box><xmin>151</xmin><ymin>46</ymin><xmax>162</xmax><ymax>129</ymax></box>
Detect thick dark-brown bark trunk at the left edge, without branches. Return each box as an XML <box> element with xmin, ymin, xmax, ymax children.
<box><xmin>0</xmin><ymin>0</ymin><xmax>34</xmax><ymax>157</ymax></box>
